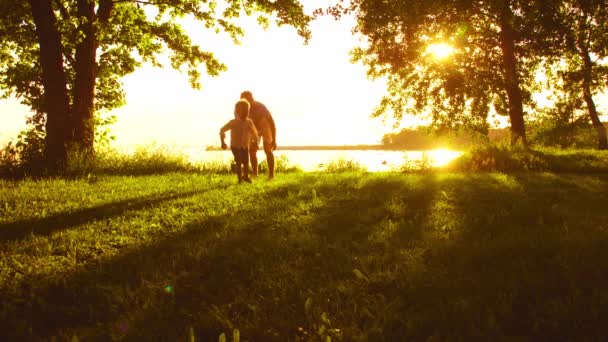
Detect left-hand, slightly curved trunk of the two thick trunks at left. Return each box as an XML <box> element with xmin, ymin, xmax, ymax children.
<box><xmin>29</xmin><ymin>0</ymin><xmax>70</xmax><ymax>171</ymax></box>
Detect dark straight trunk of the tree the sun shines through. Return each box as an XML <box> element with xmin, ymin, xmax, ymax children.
<box><xmin>500</xmin><ymin>1</ymin><xmax>528</xmax><ymax>147</ymax></box>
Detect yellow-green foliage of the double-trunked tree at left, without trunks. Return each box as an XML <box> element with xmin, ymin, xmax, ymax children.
<box><xmin>0</xmin><ymin>0</ymin><xmax>311</xmax><ymax>111</ymax></box>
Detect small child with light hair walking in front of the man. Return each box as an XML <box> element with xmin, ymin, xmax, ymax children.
<box><xmin>220</xmin><ymin>100</ymin><xmax>258</xmax><ymax>183</ymax></box>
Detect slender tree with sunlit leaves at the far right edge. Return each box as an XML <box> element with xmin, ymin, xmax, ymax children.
<box><xmin>543</xmin><ymin>0</ymin><xmax>608</xmax><ymax>149</ymax></box>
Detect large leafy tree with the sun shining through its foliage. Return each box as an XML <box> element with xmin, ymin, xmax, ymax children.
<box><xmin>330</xmin><ymin>0</ymin><xmax>556</xmax><ymax>145</ymax></box>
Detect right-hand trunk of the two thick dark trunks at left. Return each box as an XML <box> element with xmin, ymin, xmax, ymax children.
<box><xmin>72</xmin><ymin>0</ymin><xmax>97</xmax><ymax>156</ymax></box>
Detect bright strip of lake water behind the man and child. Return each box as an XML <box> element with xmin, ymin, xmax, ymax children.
<box><xmin>182</xmin><ymin>147</ymin><xmax>462</xmax><ymax>172</ymax></box>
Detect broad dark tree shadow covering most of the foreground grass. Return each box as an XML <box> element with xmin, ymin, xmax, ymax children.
<box><xmin>0</xmin><ymin>174</ymin><xmax>608</xmax><ymax>341</ymax></box>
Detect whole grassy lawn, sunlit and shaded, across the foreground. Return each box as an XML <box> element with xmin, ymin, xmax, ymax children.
<box><xmin>0</xmin><ymin>171</ymin><xmax>608</xmax><ymax>341</ymax></box>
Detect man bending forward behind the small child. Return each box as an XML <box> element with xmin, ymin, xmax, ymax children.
<box><xmin>241</xmin><ymin>91</ymin><xmax>277</xmax><ymax>179</ymax></box>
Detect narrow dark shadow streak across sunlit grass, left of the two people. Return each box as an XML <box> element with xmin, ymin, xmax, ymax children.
<box><xmin>0</xmin><ymin>186</ymin><xmax>226</xmax><ymax>242</ymax></box>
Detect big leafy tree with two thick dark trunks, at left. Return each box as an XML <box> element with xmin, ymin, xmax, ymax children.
<box><xmin>0</xmin><ymin>0</ymin><xmax>311</xmax><ymax>170</ymax></box>
